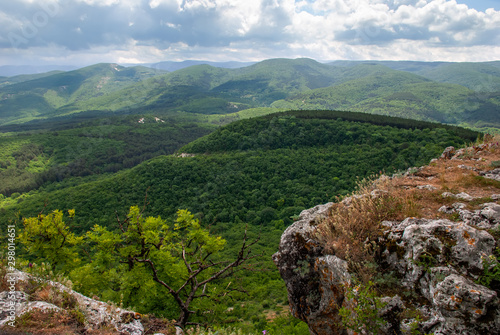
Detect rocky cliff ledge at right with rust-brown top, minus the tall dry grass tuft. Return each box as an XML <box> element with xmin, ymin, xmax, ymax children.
<box><xmin>273</xmin><ymin>144</ymin><xmax>500</xmax><ymax>335</ymax></box>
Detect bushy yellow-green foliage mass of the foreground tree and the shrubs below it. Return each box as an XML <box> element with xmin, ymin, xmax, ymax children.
<box><xmin>63</xmin><ymin>206</ymin><xmax>252</xmax><ymax>327</ymax></box>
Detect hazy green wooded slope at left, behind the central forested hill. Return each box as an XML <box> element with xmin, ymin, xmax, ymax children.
<box><xmin>0</xmin><ymin>115</ymin><xmax>213</xmax><ymax>196</ymax></box>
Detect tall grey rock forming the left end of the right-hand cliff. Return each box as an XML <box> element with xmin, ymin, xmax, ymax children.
<box><xmin>273</xmin><ymin>203</ymin><xmax>350</xmax><ymax>334</ymax></box>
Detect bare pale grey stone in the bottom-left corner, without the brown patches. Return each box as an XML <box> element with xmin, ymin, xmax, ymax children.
<box><xmin>0</xmin><ymin>271</ymin><xmax>144</xmax><ymax>335</ymax></box>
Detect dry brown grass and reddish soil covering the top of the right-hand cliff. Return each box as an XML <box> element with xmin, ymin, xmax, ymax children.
<box><xmin>318</xmin><ymin>135</ymin><xmax>500</xmax><ymax>283</ymax></box>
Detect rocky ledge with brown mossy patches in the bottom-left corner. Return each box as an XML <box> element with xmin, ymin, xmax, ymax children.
<box><xmin>0</xmin><ymin>271</ymin><xmax>171</xmax><ymax>335</ymax></box>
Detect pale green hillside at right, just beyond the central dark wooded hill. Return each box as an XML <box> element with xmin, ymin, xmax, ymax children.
<box><xmin>272</xmin><ymin>64</ymin><xmax>500</xmax><ymax>127</ymax></box>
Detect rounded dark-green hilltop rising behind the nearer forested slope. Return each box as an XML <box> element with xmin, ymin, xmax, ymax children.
<box><xmin>180</xmin><ymin>110</ymin><xmax>479</xmax><ymax>153</ymax></box>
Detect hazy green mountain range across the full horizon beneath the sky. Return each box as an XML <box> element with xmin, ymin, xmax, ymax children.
<box><xmin>0</xmin><ymin>58</ymin><xmax>500</xmax><ymax>128</ymax></box>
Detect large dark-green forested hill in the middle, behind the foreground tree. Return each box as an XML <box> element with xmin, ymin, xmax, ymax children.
<box><xmin>2</xmin><ymin>111</ymin><xmax>477</xmax><ymax>235</ymax></box>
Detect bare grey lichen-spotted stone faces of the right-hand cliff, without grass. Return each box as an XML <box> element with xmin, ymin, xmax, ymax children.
<box><xmin>273</xmin><ymin>205</ymin><xmax>500</xmax><ymax>335</ymax></box>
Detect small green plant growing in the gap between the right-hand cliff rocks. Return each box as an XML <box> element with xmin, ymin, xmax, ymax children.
<box><xmin>339</xmin><ymin>282</ymin><xmax>386</xmax><ymax>334</ymax></box>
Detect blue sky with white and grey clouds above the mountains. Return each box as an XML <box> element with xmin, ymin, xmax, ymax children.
<box><xmin>0</xmin><ymin>0</ymin><xmax>500</xmax><ymax>66</ymax></box>
